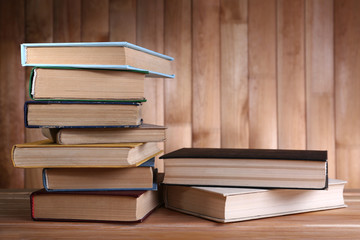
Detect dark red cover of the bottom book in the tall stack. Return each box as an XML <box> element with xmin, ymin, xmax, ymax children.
<box><xmin>30</xmin><ymin>189</ymin><xmax>160</xmax><ymax>223</ymax></box>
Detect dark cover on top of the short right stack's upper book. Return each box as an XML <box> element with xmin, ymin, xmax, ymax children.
<box><xmin>160</xmin><ymin>148</ymin><xmax>327</xmax><ymax>161</ymax></box>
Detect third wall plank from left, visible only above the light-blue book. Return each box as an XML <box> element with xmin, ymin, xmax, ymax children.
<box><xmin>53</xmin><ymin>0</ymin><xmax>81</xmax><ymax>42</ymax></box>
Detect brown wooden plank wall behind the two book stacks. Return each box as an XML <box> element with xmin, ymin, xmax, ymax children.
<box><xmin>0</xmin><ymin>0</ymin><xmax>360</xmax><ymax>188</ymax></box>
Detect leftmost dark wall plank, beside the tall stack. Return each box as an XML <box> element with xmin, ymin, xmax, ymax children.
<box><xmin>0</xmin><ymin>0</ymin><xmax>25</xmax><ymax>188</ymax></box>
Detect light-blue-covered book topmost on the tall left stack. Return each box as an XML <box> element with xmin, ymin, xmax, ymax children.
<box><xmin>21</xmin><ymin>42</ymin><xmax>174</xmax><ymax>78</ymax></box>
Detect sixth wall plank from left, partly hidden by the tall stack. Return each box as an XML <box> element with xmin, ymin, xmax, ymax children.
<box><xmin>136</xmin><ymin>0</ymin><xmax>166</xmax><ymax>172</ymax></box>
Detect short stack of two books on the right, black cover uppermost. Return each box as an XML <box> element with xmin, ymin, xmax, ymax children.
<box><xmin>161</xmin><ymin>148</ymin><xmax>346</xmax><ymax>222</ymax></box>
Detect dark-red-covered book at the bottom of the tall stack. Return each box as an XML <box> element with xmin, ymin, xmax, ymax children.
<box><xmin>30</xmin><ymin>189</ymin><xmax>159</xmax><ymax>222</ymax></box>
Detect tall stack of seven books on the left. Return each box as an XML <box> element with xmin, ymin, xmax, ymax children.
<box><xmin>12</xmin><ymin>42</ymin><xmax>174</xmax><ymax>222</ymax></box>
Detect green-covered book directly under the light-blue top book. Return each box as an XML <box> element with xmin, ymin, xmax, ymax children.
<box><xmin>29</xmin><ymin>67</ymin><xmax>146</xmax><ymax>101</ymax></box>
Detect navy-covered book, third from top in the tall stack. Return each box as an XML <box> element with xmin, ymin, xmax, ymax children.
<box><xmin>24</xmin><ymin>101</ymin><xmax>142</xmax><ymax>128</ymax></box>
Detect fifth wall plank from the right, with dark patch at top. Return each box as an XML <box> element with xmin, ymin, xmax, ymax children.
<box><xmin>220</xmin><ymin>0</ymin><xmax>249</xmax><ymax>148</ymax></box>
